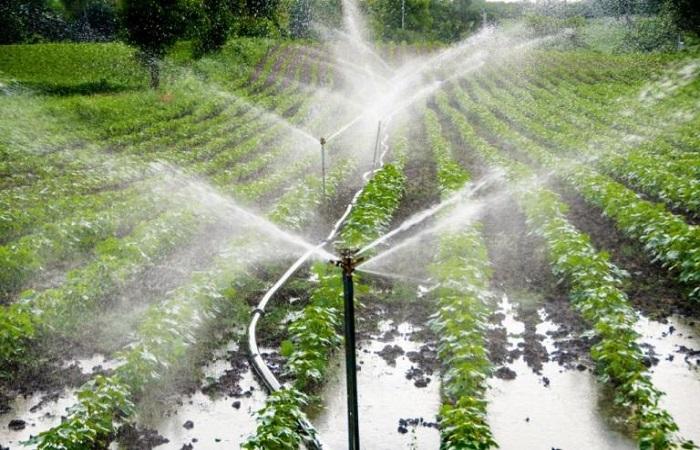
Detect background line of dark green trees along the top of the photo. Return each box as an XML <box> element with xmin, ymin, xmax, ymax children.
<box><xmin>0</xmin><ymin>0</ymin><xmax>700</xmax><ymax>86</ymax></box>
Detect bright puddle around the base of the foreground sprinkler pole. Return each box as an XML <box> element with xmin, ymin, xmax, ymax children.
<box><xmin>312</xmin><ymin>322</ymin><xmax>440</xmax><ymax>450</ymax></box>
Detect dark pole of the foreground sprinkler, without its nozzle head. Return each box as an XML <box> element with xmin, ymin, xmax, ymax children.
<box><xmin>343</xmin><ymin>262</ymin><xmax>360</xmax><ymax>450</ymax></box>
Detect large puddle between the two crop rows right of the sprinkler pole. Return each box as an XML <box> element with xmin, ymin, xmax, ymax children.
<box><xmin>487</xmin><ymin>297</ymin><xmax>637</xmax><ymax>450</ymax></box>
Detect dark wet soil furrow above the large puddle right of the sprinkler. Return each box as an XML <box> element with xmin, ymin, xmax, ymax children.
<box><xmin>470</xmin><ymin>148</ymin><xmax>593</xmax><ymax>378</ymax></box>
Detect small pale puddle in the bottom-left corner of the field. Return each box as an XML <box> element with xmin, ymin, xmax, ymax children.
<box><xmin>0</xmin><ymin>389</ymin><xmax>75</xmax><ymax>449</ymax></box>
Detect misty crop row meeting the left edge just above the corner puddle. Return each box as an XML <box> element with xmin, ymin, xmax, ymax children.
<box><xmin>0</xmin><ymin>206</ymin><xmax>205</xmax><ymax>366</ymax></box>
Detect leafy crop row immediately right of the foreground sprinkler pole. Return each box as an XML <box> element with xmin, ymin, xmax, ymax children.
<box><xmin>424</xmin><ymin>109</ymin><xmax>498</xmax><ymax>450</ymax></box>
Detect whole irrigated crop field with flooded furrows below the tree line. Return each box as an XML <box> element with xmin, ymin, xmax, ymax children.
<box><xmin>0</xmin><ymin>17</ymin><xmax>700</xmax><ymax>449</ymax></box>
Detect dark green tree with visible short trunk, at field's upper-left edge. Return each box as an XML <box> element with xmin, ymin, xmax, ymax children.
<box><xmin>118</xmin><ymin>0</ymin><xmax>197</xmax><ymax>89</ymax></box>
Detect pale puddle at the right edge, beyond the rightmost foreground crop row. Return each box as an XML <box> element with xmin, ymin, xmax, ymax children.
<box><xmin>637</xmin><ymin>316</ymin><xmax>700</xmax><ymax>443</ymax></box>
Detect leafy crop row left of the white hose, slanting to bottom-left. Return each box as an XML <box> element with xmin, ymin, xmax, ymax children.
<box><xmin>28</xmin><ymin>132</ymin><xmax>350</xmax><ymax>450</ymax></box>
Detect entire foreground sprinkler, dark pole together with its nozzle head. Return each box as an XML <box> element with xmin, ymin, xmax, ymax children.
<box><xmin>331</xmin><ymin>249</ymin><xmax>364</xmax><ymax>450</ymax></box>
